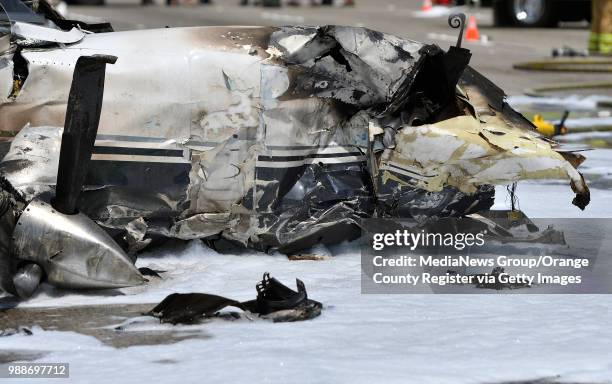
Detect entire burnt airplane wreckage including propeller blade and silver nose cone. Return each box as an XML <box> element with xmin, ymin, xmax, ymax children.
<box><xmin>0</xmin><ymin>0</ymin><xmax>589</xmax><ymax>296</ymax></box>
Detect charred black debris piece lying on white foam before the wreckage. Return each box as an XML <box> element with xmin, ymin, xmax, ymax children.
<box><xmin>146</xmin><ymin>272</ymin><xmax>322</xmax><ymax>324</ymax></box>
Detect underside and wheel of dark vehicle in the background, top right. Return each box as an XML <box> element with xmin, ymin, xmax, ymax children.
<box><xmin>491</xmin><ymin>0</ymin><xmax>591</xmax><ymax>27</ymax></box>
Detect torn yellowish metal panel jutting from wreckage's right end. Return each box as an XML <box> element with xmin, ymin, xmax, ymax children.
<box><xmin>380</xmin><ymin>116</ymin><xmax>588</xmax><ymax>208</ymax></box>
